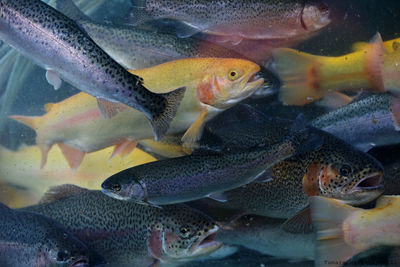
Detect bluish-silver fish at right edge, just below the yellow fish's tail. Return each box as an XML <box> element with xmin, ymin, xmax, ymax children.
<box><xmin>310</xmin><ymin>93</ymin><xmax>400</xmax><ymax>151</ymax></box>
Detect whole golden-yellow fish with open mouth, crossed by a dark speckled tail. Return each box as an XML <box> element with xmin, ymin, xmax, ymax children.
<box><xmin>10</xmin><ymin>58</ymin><xmax>264</xmax><ymax>169</ymax></box>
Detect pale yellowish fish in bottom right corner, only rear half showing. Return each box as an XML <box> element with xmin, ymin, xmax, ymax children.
<box><xmin>310</xmin><ymin>196</ymin><xmax>400</xmax><ymax>266</ymax></box>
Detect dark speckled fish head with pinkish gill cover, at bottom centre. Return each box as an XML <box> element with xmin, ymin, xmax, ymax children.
<box><xmin>149</xmin><ymin>205</ymin><xmax>222</xmax><ymax>262</ymax></box>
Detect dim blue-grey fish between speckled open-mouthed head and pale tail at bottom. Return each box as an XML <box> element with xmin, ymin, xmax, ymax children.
<box><xmin>216</xmin><ymin>215</ymin><xmax>316</xmax><ymax>261</ymax></box>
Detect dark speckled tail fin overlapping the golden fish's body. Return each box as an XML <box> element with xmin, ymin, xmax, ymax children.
<box><xmin>150</xmin><ymin>87</ymin><xmax>186</xmax><ymax>141</ymax></box>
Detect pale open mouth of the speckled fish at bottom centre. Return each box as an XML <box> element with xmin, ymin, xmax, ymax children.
<box><xmin>190</xmin><ymin>225</ymin><xmax>222</xmax><ymax>257</ymax></box>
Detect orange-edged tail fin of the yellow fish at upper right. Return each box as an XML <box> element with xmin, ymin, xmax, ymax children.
<box><xmin>273</xmin><ymin>48</ymin><xmax>323</xmax><ymax>106</ymax></box>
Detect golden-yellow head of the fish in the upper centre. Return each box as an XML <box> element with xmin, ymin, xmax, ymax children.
<box><xmin>197</xmin><ymin>58</ymin><xmax>264</xmax><ymax>109</ymax></box>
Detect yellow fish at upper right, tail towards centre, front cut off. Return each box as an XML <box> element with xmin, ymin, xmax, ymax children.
<box><xmin>274</xmin><ymin>34</ymin><xmax>400</xmax><ymax>105</ymax></box>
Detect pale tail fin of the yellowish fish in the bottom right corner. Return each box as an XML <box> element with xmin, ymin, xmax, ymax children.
<box><xmin>310</xmin><ymin>197</ymin><xmax>361</xmax><ymax>266</ymax></box>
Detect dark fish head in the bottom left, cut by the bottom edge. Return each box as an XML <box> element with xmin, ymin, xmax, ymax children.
<box><xmin>38</xmin><ymin>229</ymin><xmax>89</xmax><ymax>267</ymax></box>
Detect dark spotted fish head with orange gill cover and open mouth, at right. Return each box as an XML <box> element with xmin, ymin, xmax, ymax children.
<box><xmin>303</xmin><ymin>140</ymin><xmax>383</xmax><ymax>205</ymax></box>
